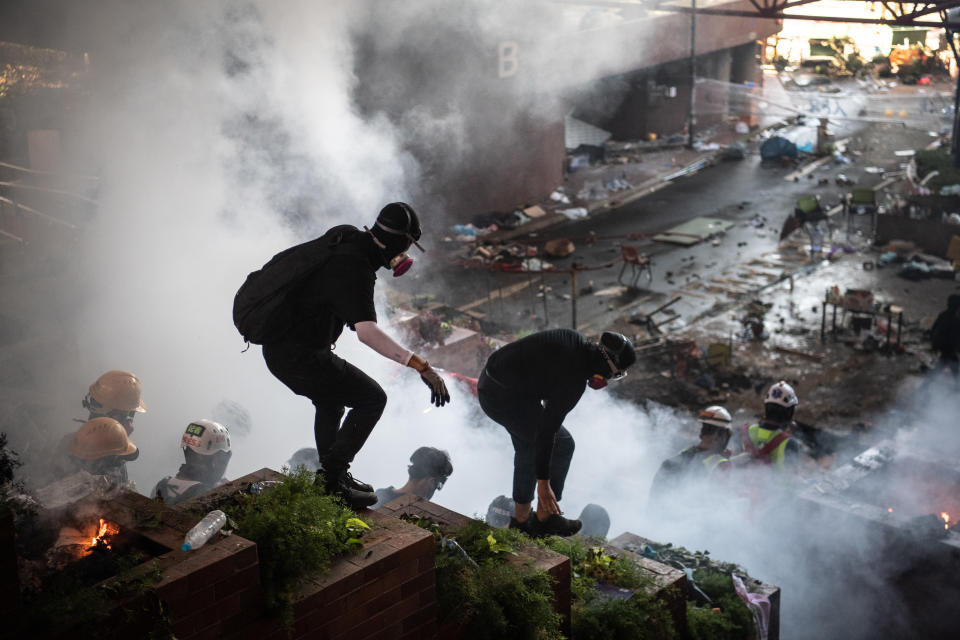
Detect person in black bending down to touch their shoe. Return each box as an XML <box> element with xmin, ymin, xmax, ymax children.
<box><xmin>477</xmin><ymin>329</ymin><xmax>636</xmax><ymax>536</ymax></box>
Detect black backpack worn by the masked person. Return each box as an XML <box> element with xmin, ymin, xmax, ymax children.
<box><xmin>233</xmin><ymin>224</ymin><xmax>365</xmax><ymax>344</ymax></box>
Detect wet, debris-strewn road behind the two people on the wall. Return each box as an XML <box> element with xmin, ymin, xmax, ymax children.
<box><xmin>398</xmin><ymin>144</ymin><xmax>852</xmax><ymax>331</ymax></box>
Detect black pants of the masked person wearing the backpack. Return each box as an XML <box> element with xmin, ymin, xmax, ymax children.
<box><xmin>263</xmin><ymin>344</ymin><xmax>387</xmax><ymax>469</ymax></box>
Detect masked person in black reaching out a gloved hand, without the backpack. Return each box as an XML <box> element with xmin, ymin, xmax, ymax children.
<box><xmin>263</xmin><ymin>202</ymin><xmax>450</xmax><ymax>508</ymax></box>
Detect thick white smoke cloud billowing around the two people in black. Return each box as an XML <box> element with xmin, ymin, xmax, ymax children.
<box><xmin>5</xmin><ymin>0</ymin><xmax>956</xmax><ymax>638</ymax></box>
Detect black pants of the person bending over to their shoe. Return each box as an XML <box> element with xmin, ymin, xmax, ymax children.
<box><xmin>477</xmin><ymin>369</ymin><xmax>575</xmax><ymax>504</ymax></box>
